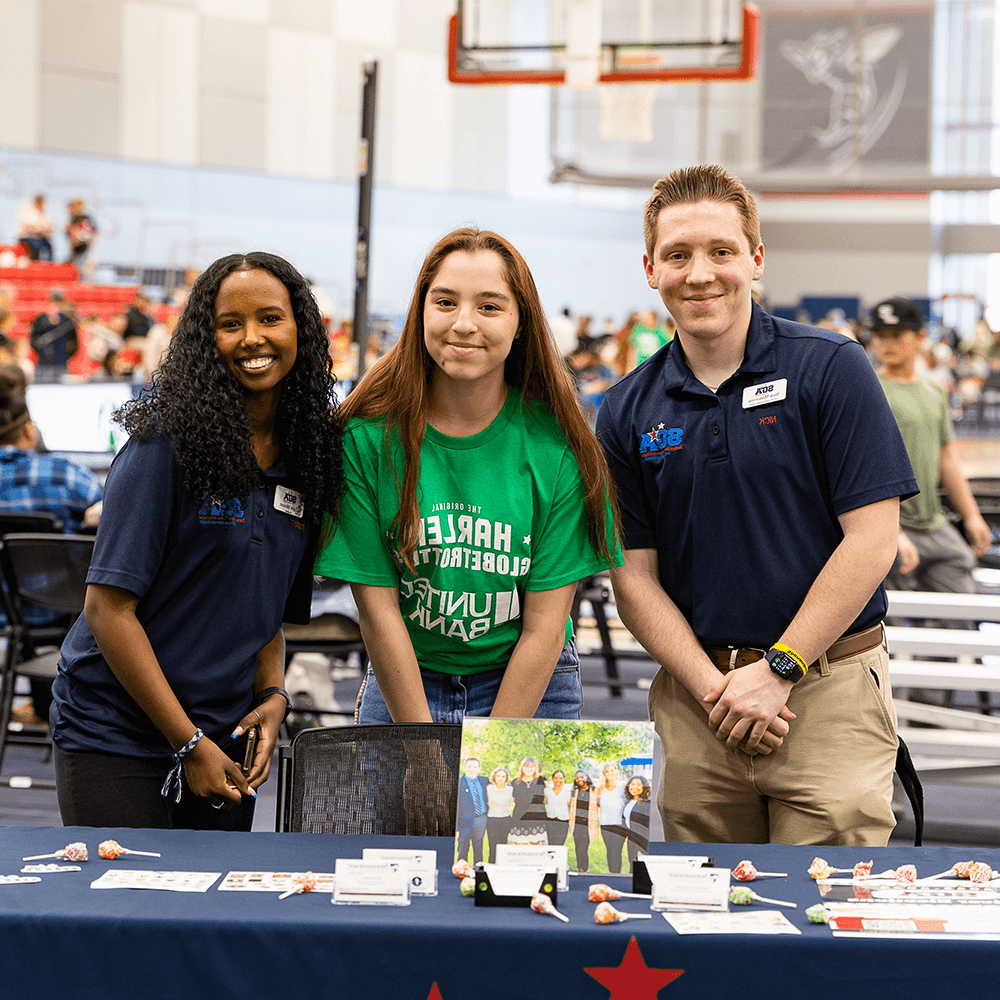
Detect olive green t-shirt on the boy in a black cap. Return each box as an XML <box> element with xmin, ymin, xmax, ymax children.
<box><xmin>879</xmin><ymin>375</ymin><xmax>952</xmax><ymax>531</ymax></box>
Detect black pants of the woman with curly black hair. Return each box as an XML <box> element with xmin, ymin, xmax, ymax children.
<box><xmin>53</xmin><ymin>736</ymin><xmax>256</xmax><ymax>831</ymax></box>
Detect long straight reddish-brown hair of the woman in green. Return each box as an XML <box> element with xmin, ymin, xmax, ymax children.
<box><xmin>340</xmin><ymin>228</ymin><xmax>617</xmax><ymax>571</ymax></box>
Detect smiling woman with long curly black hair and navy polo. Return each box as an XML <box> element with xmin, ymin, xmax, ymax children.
<box><xmin>51</xmin><ymin>253</ymin><xmax>340</xmax><ymax>830</ymax></box>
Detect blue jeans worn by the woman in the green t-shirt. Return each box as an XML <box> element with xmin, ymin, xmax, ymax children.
<box><xmin>354</xmin><ymin>639</ymin><xmax>583</xmax><ymax>722</ymax></box>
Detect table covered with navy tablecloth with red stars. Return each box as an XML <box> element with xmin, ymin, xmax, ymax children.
<box><xmin>0</xmin><ymin>827</ymin><xmax>1000</xmax><ymax>1000</ymax></box>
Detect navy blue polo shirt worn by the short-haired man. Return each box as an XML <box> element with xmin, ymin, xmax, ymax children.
<box><xmin>597</xmin><ymin>305</ymin><xmax>917</xmax><ymax>649</ymax></box>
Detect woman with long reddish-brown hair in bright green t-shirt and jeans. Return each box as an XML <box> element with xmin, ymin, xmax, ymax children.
<box><xmin>316</xmin><ymin>229</ymin><xmax>621</xmax><ymax>723</ymax></box>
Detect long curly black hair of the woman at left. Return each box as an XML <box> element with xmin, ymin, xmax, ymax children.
<box><xmin>114</xmin><ymin>251</ymin><xmax>341</xmax><ymax>526</ymax></box>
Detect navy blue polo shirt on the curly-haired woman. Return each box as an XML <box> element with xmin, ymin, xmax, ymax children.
<box><xmin>51</xmin><ymin>435</ymin><xmax>314</xmax><ymax>758</ymax></box>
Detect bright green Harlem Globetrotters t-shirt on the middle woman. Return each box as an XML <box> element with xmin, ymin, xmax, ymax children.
<box><xmin>316</xmin><ymin>388</ymin><xmax>621</xmax><ymax>674</ymax></box>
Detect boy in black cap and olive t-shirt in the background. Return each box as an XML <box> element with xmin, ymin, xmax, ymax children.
<box><xmin>870</xmin><ymin>298</ymin><xmax>991</xmax><ymax>594</ymax></box>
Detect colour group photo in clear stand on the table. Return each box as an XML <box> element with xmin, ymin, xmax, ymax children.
<box><xmin>455</xmin><ymin>718</ymin><xmax>654</xmax><ymax>874</ymax></box>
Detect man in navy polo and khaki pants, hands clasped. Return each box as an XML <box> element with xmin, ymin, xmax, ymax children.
<box><xmin>597</xmin><ymin>166</ymin><xmax>917</xmax><ymax>846</ymax></box>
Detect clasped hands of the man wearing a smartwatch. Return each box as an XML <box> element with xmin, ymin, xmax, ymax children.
<box><xmin>702</xmin><ymin>659</ymin><xmax>795</xmax><ymax>754</ymax></box>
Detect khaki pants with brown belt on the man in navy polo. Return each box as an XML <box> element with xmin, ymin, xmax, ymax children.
<box><xmin>649</xmin><ymin>646</ymin><xmax>897</xmax><ymax>847</ymax></box>
